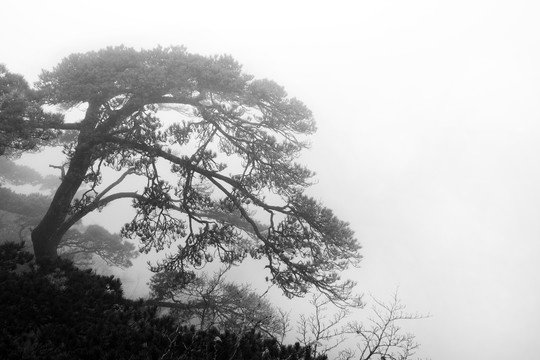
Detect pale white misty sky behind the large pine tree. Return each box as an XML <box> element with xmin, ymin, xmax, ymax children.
<box><xmin>0</xmin><ymin>0</ymin><xmax>540</xmax><ymax>360</ymax></box>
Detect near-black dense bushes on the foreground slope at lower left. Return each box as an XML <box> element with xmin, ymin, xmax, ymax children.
<box><xmin>0</xmin><ymin>243</ymin><xmax>326</xmax><ymax>360</ymax></box>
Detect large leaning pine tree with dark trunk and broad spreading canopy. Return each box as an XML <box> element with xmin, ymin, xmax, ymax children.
<box><xmin>0</xmin><ymin>46</ymin><xmax>360</xmax><ymax>300</ymax></box>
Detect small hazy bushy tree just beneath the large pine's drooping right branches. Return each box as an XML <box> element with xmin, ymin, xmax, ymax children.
<box><xmin>149</xmin><ymin>266</ymin><xmax>289</xmax><ymax>339</ymax></box>
